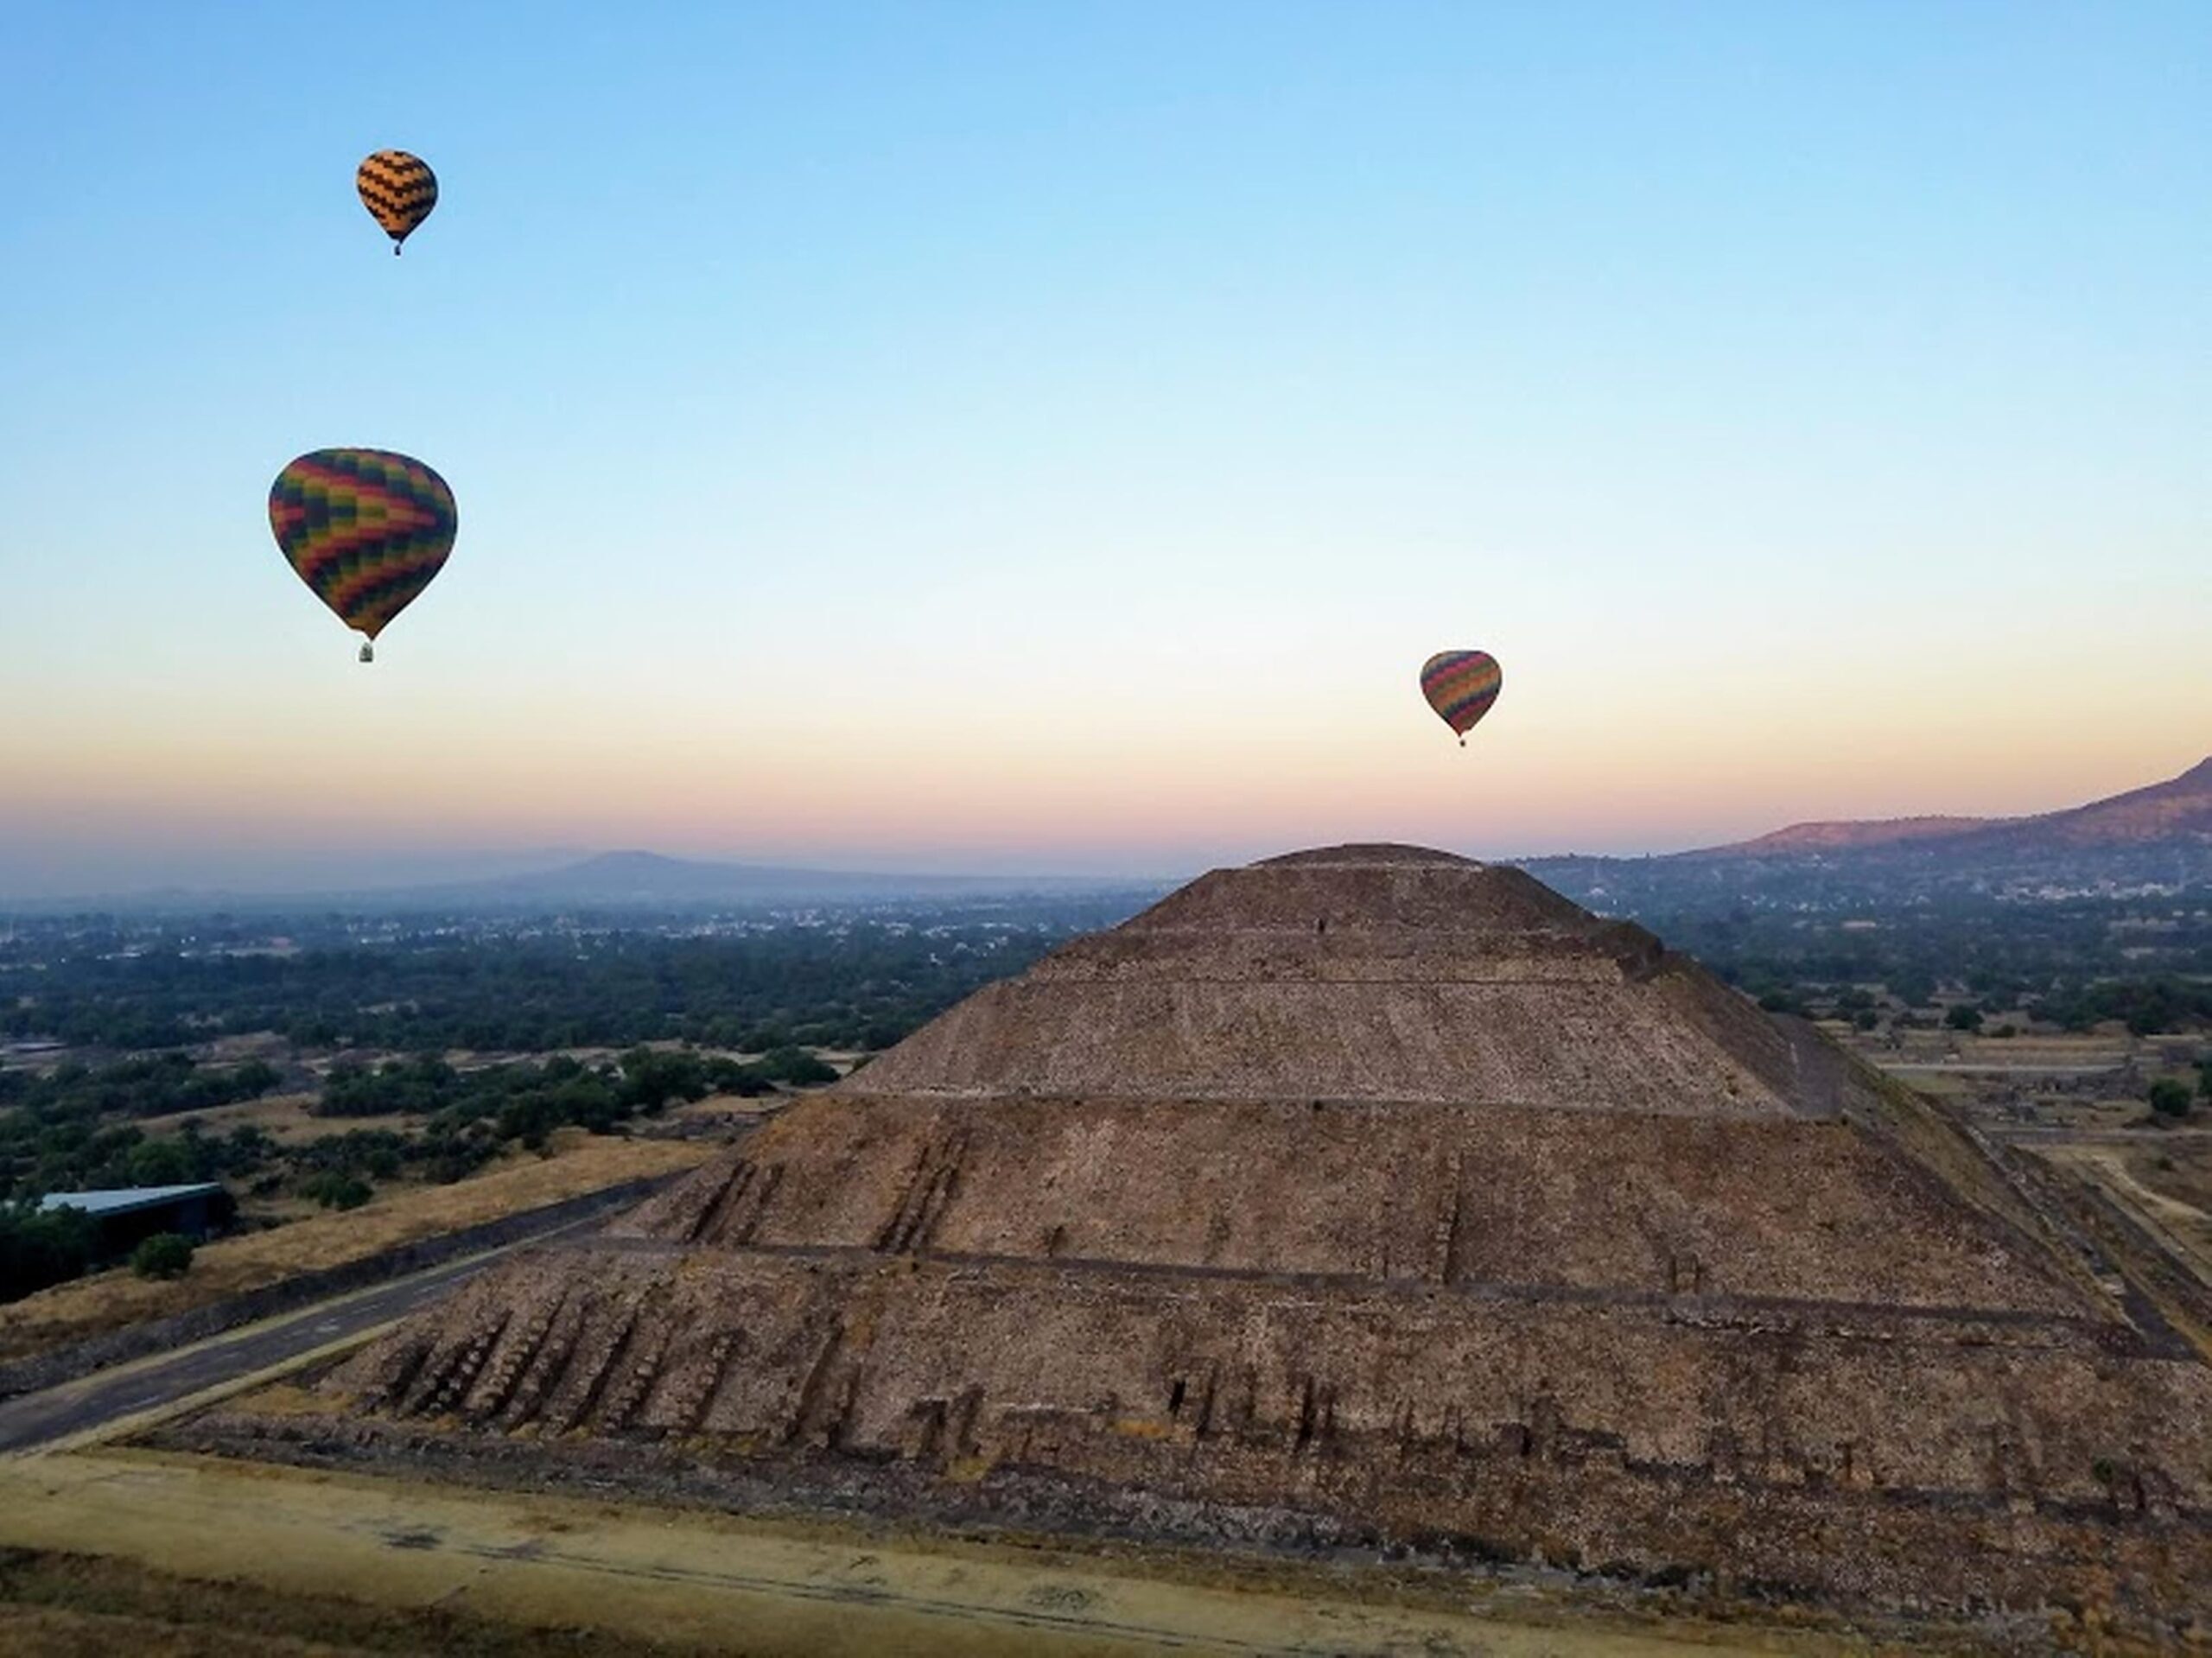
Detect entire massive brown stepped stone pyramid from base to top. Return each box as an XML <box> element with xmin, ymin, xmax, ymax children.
<box><xmin>298</xmin><ymin>847</ymin><xmax>2212</xmax><ymax>1616</ymax></box>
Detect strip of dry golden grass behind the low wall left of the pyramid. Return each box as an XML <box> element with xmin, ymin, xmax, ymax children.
<box><xmin>0</xmin><ymin>1129</ymin><xmax>719</xmax><ymax>1360</ymax></box>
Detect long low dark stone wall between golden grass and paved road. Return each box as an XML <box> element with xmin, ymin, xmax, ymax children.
<box><xmin>0</xmin><ymin>1174</ymin><xmax>679</xmax><ymax>1400</ymax></box>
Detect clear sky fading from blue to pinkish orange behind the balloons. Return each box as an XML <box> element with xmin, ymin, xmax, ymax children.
<box><xmin>0</xmin><ymin>0</ymin><xmax>2212</xmax><ymax>893</ymax></box>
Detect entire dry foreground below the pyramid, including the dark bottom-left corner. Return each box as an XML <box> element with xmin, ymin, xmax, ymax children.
<box><xmin>0</xmin><ymin>1450</ymin><xmax>2035</xmax><ymax>1658</ymax></box>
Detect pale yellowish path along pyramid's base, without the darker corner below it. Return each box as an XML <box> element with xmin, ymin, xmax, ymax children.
<box><xmin>0</xmin><ymin>1450</ymin><xmax>1885</xmax><ymax>1658</ymax></box>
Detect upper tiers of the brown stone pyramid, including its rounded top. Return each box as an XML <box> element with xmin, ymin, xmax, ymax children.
<box><xmin>852</xmin><ymin>847</ymin><xmax>1845</xmax><ymax>1116</ymax></box>
